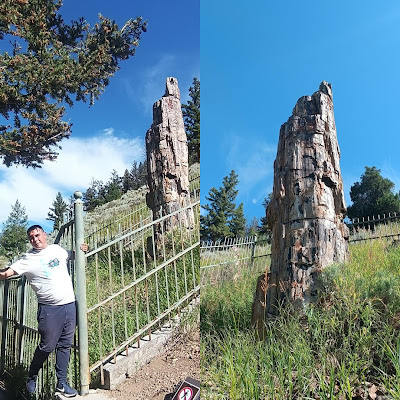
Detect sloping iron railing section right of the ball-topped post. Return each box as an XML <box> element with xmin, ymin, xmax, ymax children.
<box><xmin>86</xmin><ymin>201</ymin><xmax>200</xmax><ymax>384</ymax></box>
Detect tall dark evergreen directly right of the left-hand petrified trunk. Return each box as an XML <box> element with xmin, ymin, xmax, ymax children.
<box><xmin>182</xmin><ymin>78</ymin><xmax>200</xmax><ymax>165</ymax></box>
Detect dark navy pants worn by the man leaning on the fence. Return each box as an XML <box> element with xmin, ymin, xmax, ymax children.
<box><xmin>29</xmin><ymin>302</ymin><xmax>76</xmax><ymax>382</ymax></box>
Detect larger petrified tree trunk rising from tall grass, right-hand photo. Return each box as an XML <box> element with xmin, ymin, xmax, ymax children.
<box><xmin>253</xmin><ymin>82</ymin><xmax>348</xmax><ymax>332</ymax></box>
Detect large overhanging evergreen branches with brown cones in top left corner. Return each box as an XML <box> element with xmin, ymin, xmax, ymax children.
<box><xmin>0</xmin><ymin>0</ymin><xmax>147</xmax><ymax>167</ymax></box>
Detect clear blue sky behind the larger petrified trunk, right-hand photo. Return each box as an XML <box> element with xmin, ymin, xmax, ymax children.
<box><xmin>200</xmin><ymin>0</ymin><xmax>400</xmax><ymax>223</ymax></box>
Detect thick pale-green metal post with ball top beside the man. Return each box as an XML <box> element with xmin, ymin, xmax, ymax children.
<box><xmin>74</xmin><ymin>192</ymin><xmax>90</xmax><ymax>396</ymax></box>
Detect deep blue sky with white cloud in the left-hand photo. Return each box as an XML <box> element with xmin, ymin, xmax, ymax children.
<box><xmin>0</xmin><ymin>0</ymin><xmax>200</xmax><ymax>230</ymax></box>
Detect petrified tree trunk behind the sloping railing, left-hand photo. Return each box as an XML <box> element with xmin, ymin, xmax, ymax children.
<box><xmin>146</xmin><ymin>78</ymin><xmax>194</xmax><ymax>250</ymax></box>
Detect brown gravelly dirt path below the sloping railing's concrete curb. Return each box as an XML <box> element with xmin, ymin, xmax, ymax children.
<box><xmin>97</xmin><ymin>328</ymin><xmax>200</xmax><ymax>400</ymax></box>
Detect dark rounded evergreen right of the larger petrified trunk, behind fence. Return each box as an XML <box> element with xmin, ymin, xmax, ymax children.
<box><xmin>347</xmin><ymin>167</ymin><xmax>400</xmax><ymax>218</ymax></box>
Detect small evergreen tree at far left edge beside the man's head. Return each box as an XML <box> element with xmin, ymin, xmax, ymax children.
<box><xmin>0</xmin><ymin>200</ymin><xmax>28</xmax><ymax>261</ymax></box>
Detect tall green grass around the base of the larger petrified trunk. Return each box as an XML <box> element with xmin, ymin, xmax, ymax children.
<box><xmin>201</xmin><ymin>240</ymin><xmax>400</xmax><ymax>400</ymax></box>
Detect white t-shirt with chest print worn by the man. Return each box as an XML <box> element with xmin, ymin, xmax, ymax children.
<box><xmin>10</xmin><ymin>244</ymin><xmax>75</xmax><ymax>306</ymax></box>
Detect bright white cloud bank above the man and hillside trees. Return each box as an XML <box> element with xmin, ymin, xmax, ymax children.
<box><xmin>0</xmin><ymin>128</ymin><xmax>144</xmax><ymax>230</ymax></box>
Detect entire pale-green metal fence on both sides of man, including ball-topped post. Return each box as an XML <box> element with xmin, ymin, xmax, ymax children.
<box><xmin>0</xmin><ymin>183</ymin><xmax>200</xmax><ymax>399</ymax></box>
